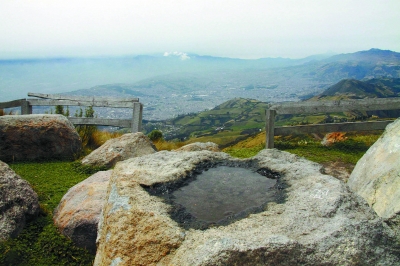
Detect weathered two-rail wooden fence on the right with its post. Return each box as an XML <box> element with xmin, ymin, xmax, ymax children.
<box><xmin>265</xmin><ymin>98</ymin><xmax>400</xmax><ymax>149</ymax></box>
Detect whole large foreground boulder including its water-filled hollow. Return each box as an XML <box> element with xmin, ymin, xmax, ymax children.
<box><xmin>94</xmin><ymin>149</ymin><xmax>400</xmax><ymax>266</ymax></box>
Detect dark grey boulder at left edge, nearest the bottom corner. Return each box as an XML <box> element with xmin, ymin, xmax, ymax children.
<box><xmin>0</xmin><ymin>161</ymin><xmax>39</xmax><ymax>241</ymax></box>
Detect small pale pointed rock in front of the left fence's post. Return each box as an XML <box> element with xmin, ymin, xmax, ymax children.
<box><xmin>81</xmin><ymin>132</ymin><xmax>157</xmax><ymax>167</ymax></box>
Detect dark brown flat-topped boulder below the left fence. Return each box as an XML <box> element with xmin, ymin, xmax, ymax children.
<box><xmin>0</xmin><ymin>115</ymin><xmax>82</xmax><ymax>162</ymax></box>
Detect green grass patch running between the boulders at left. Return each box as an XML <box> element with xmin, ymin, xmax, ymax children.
<box><xmin>0</xmin><ymin>161</ymin><xmax>94</xmax><ymax>265</ymax></box>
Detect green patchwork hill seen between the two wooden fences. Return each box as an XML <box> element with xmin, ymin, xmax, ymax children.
<box><xmin>143</xmin><ymin>98</ymin><xmax>267</xmax><ymax>146</ymax></box>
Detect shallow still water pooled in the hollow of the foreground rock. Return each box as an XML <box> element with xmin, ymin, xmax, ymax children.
<box><xmin>172</xmin><ymin>166</ymin><xmax>277</xmax><ymax>223</ymax></box>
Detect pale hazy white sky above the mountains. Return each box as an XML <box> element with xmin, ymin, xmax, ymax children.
<box><xmin>0</xmin><ymin>0</ymin><xmax>400</xmax><ymax>58</ymax></box>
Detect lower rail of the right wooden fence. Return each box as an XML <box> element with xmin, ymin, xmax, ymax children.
<box><xmin>274</xmin><ymin>121</ymin><xmax>393</xmax><ymax>135</ymax></box>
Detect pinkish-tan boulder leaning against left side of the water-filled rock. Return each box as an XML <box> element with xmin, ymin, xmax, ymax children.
<box><xmin>53</xmin><ymin>170</ymin><xmax>112</xmax><ymax>253</ymax></box>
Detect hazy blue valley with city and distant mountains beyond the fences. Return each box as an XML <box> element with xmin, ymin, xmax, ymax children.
<box><xmin>0</xmin><ymin>49</ymin><xmax>400</xmax><ymax>120</ymax></box>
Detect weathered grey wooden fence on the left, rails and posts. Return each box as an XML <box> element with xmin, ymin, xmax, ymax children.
<box><xmin>0</xmin><ymin>93</ymin><xmax>143</xmax><ymax>132</ymax></box>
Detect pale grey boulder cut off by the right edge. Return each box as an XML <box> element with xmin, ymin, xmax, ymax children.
<box><xmin>347</xmin><ymin>119</ymin><xmax>400</xmax><ymax>235</ymax></box>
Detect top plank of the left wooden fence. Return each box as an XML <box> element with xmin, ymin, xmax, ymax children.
<box><xmin>28</xmin><ymin>92</ymin><xmax>139</xmax><ymax>102</ymax></box>
